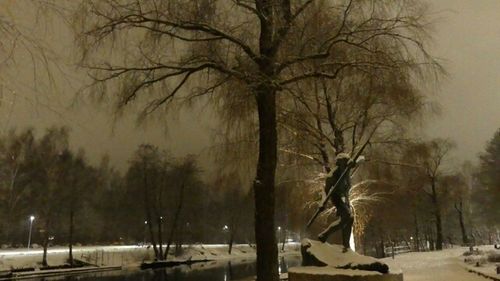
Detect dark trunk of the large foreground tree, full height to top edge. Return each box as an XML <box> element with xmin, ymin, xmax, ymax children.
<box><xmin>253</xmin><ymin>0</ymin><xmax>282</xmax><ymax>281</ymax></box>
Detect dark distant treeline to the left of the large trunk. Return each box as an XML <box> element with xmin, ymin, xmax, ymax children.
<box><xmin>0</xmin><ymin>128</ymin><xmax>253</xmax><ymax>247</ymax></box>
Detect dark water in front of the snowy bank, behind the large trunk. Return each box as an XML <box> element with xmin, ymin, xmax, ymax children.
<box><xmin>30</xmin><ymin>255</ymin><xmax>300</xmax><ymax>281</ymax></box>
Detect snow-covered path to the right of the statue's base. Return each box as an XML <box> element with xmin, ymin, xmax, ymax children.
<box><xmin>383</xmin><ymin>247</ymin><xmax>487</xmax><ymax>281</ymax></box>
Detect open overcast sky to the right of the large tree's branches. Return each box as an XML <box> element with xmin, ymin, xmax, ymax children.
<box><xmin>425</xmin><ymin>0</ymin><xmax>500</xmax><ymax>165</ymax></box>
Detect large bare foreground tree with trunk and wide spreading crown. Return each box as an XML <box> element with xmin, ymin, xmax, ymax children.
<box><xmin>74</xmin><ymin>0</ymin><xmax>442</xmax><ymax>281</ymax></box>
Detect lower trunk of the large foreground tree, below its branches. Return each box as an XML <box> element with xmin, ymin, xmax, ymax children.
<box><xmin>254</xmin><ymin>85</ymin><xmax>279</xmax><ymax>281</ymax></box>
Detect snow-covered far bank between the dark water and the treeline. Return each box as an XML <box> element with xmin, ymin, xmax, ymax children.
<box><xmin>0</xmin><ymin>243</ymin><xmax>300</xmax><ymax>270</ymax></box>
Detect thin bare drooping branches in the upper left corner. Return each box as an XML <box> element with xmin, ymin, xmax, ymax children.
<box><xmin>0</xmin><ymin>0</ymin><xmax>63</xmax><ymax>101</ymax></box>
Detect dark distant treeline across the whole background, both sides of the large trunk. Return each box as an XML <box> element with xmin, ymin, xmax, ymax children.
<box><xmin>0</xmin><ymin>128</ymin><xmax>500</xmax><ymax>258</ymax></box>
